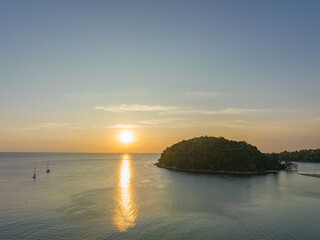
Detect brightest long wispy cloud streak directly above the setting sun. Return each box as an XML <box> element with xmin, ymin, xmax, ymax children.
<box><xmin>94</xmin><ymin>104</ymin><xmax>176</xmax><ymax>113</ymax></box>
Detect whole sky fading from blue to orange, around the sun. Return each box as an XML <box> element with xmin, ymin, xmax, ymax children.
<box><xmin>0</xmin><ymin>0</ymin><xmax>320</xmax><ymax>153</ymax></box>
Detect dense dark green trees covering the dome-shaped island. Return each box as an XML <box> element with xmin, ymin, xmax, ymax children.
<box><xmin>158</xmin><ymin>136</ymin><xmax>285</xmax><ymax>172</ymax></box>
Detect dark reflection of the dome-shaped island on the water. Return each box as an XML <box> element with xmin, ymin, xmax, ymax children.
<box><xmin>161</xmin><ymin>169</ymin><xmax>279</xmax><ymax>219</ymax></box>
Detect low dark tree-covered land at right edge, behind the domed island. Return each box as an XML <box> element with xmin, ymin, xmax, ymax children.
<box><xmin>267</xmin><ymin>148</ymin><xmax>320</xmax><ymax>163</ymax></box>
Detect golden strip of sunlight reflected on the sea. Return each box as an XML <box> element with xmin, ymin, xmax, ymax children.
<box><xmin>114</xmin><ymin>155</ymin><xmax>137</xmax><ymax>232</ymax></box>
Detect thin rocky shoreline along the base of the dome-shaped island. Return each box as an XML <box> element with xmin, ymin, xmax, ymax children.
<box><xmin>154</xmin><ymin>163</ymin><xmax>279</xmax><ymax>175</ymax></box>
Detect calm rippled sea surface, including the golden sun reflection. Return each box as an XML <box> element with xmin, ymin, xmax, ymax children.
<box><xmin>0</xmin><ymin>153</ymin><xmax>320</xmax><ymax>240</ymax></box>
